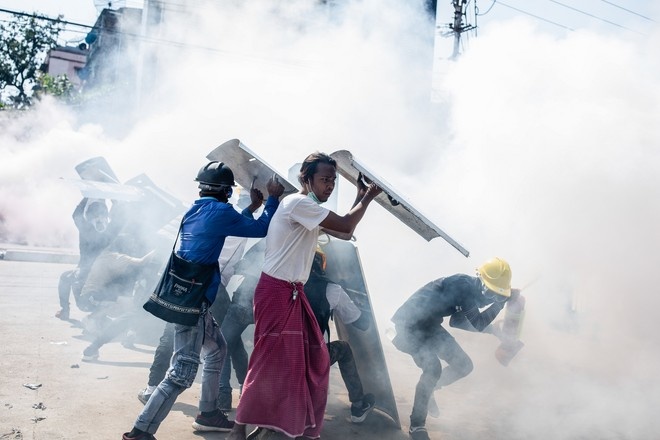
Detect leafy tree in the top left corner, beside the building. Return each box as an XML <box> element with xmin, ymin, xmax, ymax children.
<box><xmin>0</xmin><ymin>14</ymin><xmax>64</xmax><ymax>108</ymax></box>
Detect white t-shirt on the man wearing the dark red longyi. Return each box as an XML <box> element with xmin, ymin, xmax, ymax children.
<box><xmin>263</xmin><ymin>193</ymin><xmax>330</xmax><ymax>283</ymax></box>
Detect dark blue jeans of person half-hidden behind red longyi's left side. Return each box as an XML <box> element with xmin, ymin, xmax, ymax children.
<box><xmin>220</xmin><ymin>303</ymin><xmax>254</xmax><ymax>394</ymax></box>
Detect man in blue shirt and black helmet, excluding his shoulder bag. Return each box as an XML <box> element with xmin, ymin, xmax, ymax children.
<box><xmin>122</xmin><ymin>161</ymin><xmax>284</xmax><ymax>440</ymax></box>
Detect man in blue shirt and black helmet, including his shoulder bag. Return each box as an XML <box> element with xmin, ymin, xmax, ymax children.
<box><xmin>122</xmin><ymin>161</ymin><xmax>284</xmax><ymax>440</ymax></box>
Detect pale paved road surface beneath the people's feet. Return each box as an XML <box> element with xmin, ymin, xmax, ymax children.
<box><xmin>0</xmin><ymin>254</ymin><xmax>511</xmax><ymax>440</ymax></box>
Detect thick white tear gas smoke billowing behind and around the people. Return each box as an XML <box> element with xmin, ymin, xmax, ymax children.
<box><xmin>0</xmin><ymin>1</ymin><xmax>660</xmax><ymax>439</ymax></box>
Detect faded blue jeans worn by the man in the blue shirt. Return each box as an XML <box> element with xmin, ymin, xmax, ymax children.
<box><xmin>135</xmin><ymin>311</ymin><xmax>227</xmax><ymax>434</ymax></box>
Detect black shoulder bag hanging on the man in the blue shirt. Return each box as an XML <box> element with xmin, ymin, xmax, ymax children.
<box><xmin>142</xmin><ymin>220</ymin><xmax>220</xmax><ymax>326</ymax></box>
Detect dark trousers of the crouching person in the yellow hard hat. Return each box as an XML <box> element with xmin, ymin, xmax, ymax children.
<box><xmin>392</xmin><ymin>326</ymin><xmax>473</xmax><ymax>426</ymax></box>
